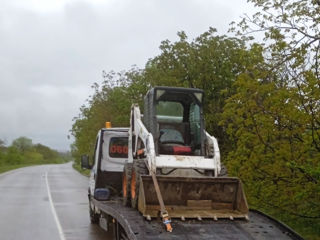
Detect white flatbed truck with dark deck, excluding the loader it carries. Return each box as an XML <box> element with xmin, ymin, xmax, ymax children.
<box><xmin>81</xmin><ymin>124</ymin><xmax>303</xmax><ymax>240</ymax></box>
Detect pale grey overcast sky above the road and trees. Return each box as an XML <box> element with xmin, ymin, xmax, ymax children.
<box><xmin>0</xmin><ymin>0</ymin><xmax>252</xmax><ymax>150</ymax></box>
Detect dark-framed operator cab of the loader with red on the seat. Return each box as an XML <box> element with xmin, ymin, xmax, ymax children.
<box><xmin>143</xmin><ymin>87</ymin><xmax>204</xmax><ymax>156</ymax></box>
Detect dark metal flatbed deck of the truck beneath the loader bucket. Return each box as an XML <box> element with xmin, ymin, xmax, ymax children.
<box><xmin>93</xmin><ymin>200</ymin><xmax>303</xmax><ymax>240</ymax></box>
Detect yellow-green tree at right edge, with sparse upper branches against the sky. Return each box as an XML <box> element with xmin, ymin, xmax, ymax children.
<box><xmin>221</xmin><ymin>0</ymin><xmax>320</xmax><ymax>238</ymax></box>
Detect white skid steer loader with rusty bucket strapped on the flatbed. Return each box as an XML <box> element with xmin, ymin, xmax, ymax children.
<box><xmin>122</xmin><ymin>87</ymin><xmax>248</xmax><ymax>231</ymax></box>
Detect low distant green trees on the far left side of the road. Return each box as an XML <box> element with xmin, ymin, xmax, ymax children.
<box><xmin>0</xmin><ymin>137</ymin><xmax>70</xmax><ymax>169</ymax></box>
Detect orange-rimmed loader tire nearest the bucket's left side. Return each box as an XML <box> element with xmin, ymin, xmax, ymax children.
<box><xmin>130</xmin><ymin>159</ymin><xmax>148</xmax><ymax>208</ymax></box>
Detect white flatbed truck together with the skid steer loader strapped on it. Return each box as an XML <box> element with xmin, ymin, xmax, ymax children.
<box><xmin>81</xmin><ymin>87</ymin><xmax>303</xmax><ymax>240</ymax></box>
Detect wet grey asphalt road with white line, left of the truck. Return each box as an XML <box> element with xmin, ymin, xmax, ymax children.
<box><xmin>0</xmin><ymin>163</ymin><xmax>112</xmax><ymax>240</ymax></box>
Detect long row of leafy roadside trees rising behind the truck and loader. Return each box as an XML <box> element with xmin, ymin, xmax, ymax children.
<box><xmin>71</xmin><ymin>0</ymin><xmax>320</xmax><ymax>239</ymax></box>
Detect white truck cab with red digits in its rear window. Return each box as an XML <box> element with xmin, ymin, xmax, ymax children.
<box><xmin>81</xmin><ymin>125</ymin><xmax>128</xmax><ymax>223</ymax></box>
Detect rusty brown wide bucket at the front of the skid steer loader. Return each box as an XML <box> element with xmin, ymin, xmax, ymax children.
<box><xmin>138</xmin><ymin>176</ymin><xmax>249</xmax><ymax>220</ymax></box>
